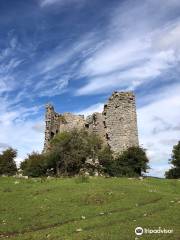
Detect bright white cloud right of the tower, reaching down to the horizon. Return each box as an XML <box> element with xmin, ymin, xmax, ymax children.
<box><xmin>137</xmin><ymin>85</ymin><xmax>180</xmax><ymax>175</ymax></box>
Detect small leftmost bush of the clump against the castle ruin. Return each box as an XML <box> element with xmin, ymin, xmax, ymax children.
<box><xmin>20</xmin><ymin>152</ymin><xmax>47</xmax><ymax>177</ymax></box>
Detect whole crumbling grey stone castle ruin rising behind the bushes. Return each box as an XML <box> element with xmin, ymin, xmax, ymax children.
<box><xmin>43</xmin><ymin>92</ymin><xmax>138</xmax><ymax>153</ymax></box>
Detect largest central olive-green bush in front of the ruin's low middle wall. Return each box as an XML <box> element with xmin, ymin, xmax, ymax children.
<box><xmin>46</xmin><ymin>129</ymin><xmax>102</xmax><ymax>176</ymax></box>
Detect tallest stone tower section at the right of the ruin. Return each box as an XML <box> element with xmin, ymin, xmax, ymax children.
<box><xmin>103</xmin><ymin>92</ymin><xmax>138</xmax><ymax>153</ymax></box>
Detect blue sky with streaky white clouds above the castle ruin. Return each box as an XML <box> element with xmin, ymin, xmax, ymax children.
<box><xmin>0</xmin><ymin>0</ymin><xmax>180</xmax><ymax>177</ymax></box>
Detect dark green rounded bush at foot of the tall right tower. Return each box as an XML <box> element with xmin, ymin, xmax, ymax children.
<box><xmin>111</xmin><ymin>147</ymin><xmax>149</xmax><ymax>177</ymax></box>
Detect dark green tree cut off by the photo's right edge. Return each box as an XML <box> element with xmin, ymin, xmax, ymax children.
<box><xmin>165</xmin><ymin>141</ymin><xmax>180</xmax><ymax>178</ymax></box>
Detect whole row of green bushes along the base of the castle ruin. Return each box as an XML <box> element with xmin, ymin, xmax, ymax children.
<box><xmin>21</xmin><ymin>129</ymin><xmax>148</xmax><ymax>177</ymax></box>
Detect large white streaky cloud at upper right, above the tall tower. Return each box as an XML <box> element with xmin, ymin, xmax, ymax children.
<box><xmin>76</xmin><ymin>1</ymin><xmax>180</xmax><ymax>95</ymax></box>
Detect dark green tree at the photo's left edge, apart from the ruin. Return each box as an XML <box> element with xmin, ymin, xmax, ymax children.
<box><xmin>0</xmin><ymin>148</ymin><xmax>17</xmax><ymax>175</ymax></box>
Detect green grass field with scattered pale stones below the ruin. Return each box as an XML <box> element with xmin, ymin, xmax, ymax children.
<box><xmin>0</xmin><ymin>177</ymin><xmax>180</xmax><ymax>240</ymax></box>
